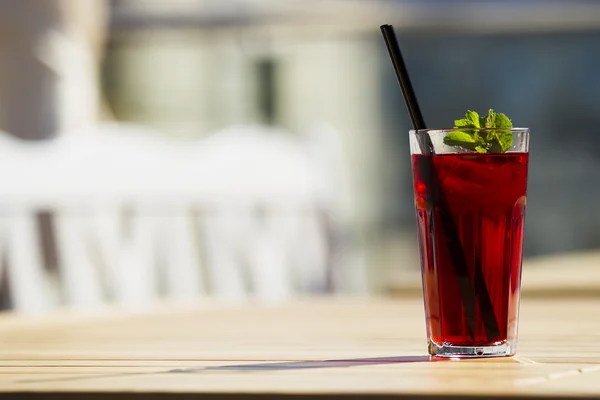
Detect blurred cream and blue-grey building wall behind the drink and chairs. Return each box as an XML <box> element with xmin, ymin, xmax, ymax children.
<box><xmin>106</xmin><ymin>0</ymin><xmax>600</xmax><ymax>292</ymax></box>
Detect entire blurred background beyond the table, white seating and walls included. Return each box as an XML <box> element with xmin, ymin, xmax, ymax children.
<box><xmin>0</xmin><ymin>0</ymin><xmax>600</xmax><ymax>311</ymax></box>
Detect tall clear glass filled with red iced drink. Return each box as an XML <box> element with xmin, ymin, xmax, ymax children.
<box><xmin>410</xmin><ymin>128</ymin><xmax>529</xmax><ymax>357</ymax></box>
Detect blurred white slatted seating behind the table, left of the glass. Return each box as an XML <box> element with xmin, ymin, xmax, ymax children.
<box><xmin>0</xmin><ymin>124</ymin><xmax>364</xmax><ymax>312</ymax></box>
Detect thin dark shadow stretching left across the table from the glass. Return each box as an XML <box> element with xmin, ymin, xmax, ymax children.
<box><xmin>169</xmin><ymin>356</ymin><xmax>443</xmax><ymax>373</ymax></box>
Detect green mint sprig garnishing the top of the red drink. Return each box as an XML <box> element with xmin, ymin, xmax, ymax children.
<box><xmin>444</xmin><ymin>109</ymin><xmax>512</xmax><ymax>153</ymax></box>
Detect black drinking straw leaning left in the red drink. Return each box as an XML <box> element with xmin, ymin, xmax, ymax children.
<box><xmin>381</xmin><ymin>25</ymin><xmax>500</xmax><ymax>340</ymax></box>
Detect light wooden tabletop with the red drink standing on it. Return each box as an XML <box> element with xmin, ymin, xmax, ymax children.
<box><xmin>0</xmin><ymin>296</ymin><xmax>600</xmax><ymax>399</ymax></box>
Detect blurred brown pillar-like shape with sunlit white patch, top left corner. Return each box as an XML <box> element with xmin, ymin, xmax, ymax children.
<box><xmin>0</xmin><ymin>0</ymin><xmax>108</xmax><ymax>140</ymax></box>
